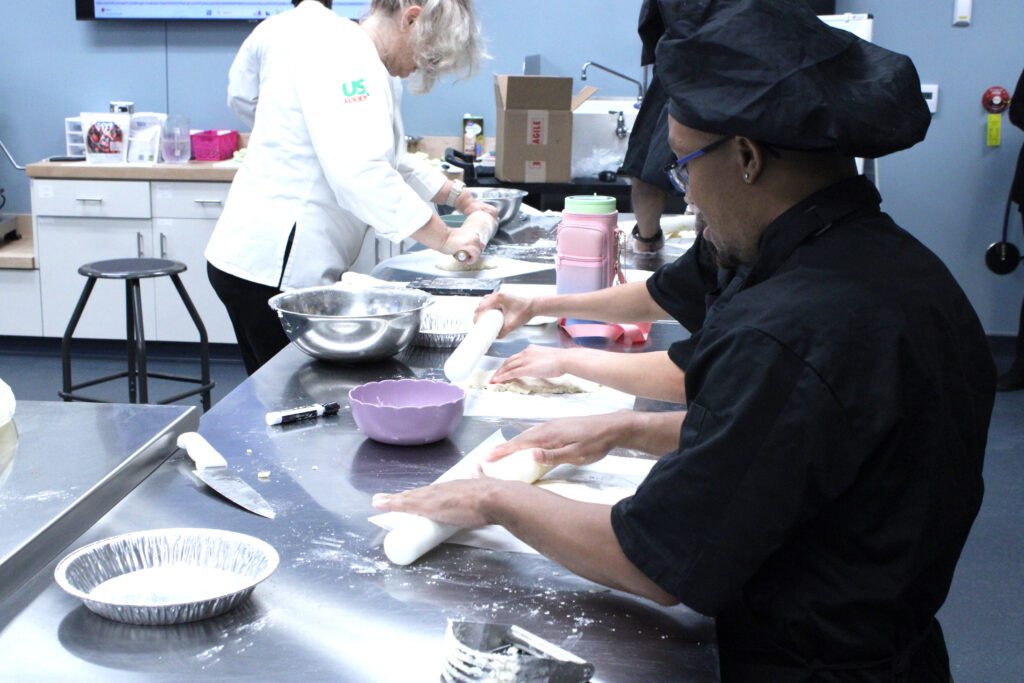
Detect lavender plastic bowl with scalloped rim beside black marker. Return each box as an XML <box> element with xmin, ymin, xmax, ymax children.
<box><xmin>348</xmin><ymin>380</ymin><xmax>466</xmax><ymax>445</ymax></box>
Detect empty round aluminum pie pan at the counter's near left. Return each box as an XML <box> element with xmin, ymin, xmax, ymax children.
<box><xmin>53</xmin><ymin>528</ymin><xmax>281</xmax><ymax>626</ymax></box>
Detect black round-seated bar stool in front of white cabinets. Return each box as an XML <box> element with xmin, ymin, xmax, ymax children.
<box><xmin>57</xmin><ymin>258</ymin><xmax>214</xmax><ymax>411</ymax></box>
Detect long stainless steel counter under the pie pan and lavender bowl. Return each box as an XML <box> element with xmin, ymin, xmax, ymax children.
<box><xmin>0</xmin><ymin>228</ymin><xmax>718</xmax><ymax>682</ymax></box>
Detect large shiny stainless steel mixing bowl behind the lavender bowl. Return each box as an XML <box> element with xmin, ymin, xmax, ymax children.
<box><xmin>267</xmin><ymin>286</ymin><xmax>432</xmax><ymax>362</ymax></box>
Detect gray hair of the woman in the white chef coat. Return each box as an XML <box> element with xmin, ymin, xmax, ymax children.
<box><xmin>370</xmin><ymin>0</ymin><xmax>487</xmax><ymax>92</ymax></box>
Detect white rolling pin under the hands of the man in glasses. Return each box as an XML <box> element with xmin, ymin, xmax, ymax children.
<box><xmin>384</xmin><ymin>449</ymin><xmax>551</xmax><ymax>566</ymax></box>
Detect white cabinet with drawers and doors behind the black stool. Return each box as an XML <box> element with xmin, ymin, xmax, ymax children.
<box><xmin>29</xmin><ymin>179</ymin><xmax>234</xmax><ymax>343</ymax></box>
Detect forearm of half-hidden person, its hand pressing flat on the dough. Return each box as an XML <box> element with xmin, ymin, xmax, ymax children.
<box><xmin>561</xmin><ymin>347</ymin><xmax>686</xmax><ymax>403</ymax></box>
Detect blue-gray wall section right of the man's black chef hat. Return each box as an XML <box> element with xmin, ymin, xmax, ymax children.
<box><xmin>837</xmin><ymin>0</ymin><xmax>1024</xmax><ymax>335</ymax></box>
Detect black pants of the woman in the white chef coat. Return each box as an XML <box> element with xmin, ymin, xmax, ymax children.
<box><xmin>206</xmin><ymin>263</ymin><xmax>289</xmax><ymax>375</ymax></box>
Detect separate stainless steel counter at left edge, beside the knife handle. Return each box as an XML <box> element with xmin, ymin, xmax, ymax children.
<box><xmin>0</xmin><ymin>401</ymin><xmax>199</xmax><ymax>601</ymax></box>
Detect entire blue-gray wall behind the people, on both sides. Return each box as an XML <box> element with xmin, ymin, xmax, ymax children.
<box><xmin>0</xmin><ymin>0</ymin><xmax>1024</xmax><ymax>334</ymax></box>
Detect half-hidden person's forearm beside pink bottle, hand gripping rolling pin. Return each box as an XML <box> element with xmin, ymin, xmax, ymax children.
<box><xmin>530</xmin><ymin>283</ymin><xmax>667</xmax><ymax>323</ymax></box>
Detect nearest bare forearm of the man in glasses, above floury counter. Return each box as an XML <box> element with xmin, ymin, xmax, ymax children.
<box><xmin>484</xmin><ymin>483</ymin><xmax>679</xmax><ymax>605</ymax></box>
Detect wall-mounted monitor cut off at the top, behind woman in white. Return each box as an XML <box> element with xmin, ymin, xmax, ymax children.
<box><xmin>75</xmin><ymin>0</ymin><xmax>370</xmax><ymax>22</ymax></box>
